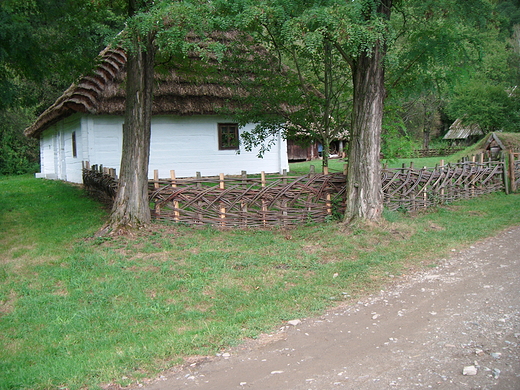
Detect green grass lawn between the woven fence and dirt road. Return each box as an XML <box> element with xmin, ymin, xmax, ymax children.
<box><xmin>0</xmin><ymin>174</ymin><xmax>520</xmax><ymax>390</ymax></box>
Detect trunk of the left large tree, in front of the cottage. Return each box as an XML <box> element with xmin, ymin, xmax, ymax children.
<box><xmin>108</xmin><ymin>33</ymin><xmax>155</xmax><ymax>232</ymax></box>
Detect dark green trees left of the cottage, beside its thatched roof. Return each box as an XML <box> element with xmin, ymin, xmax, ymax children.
<box><xmin>0</xmin><ymin>0</ymin><xmax>125</xmax><ymax>174</ymax></box>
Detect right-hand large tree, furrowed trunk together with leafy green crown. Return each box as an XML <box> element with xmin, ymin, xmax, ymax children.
<box><xmin>213</xmin><ymin>0</ymin><xmax>516</xmax><ymax>222</ymax></box>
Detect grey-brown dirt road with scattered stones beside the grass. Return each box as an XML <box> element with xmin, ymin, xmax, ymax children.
<box><xmin>136</xmin><ymin>227</ymin><xmax>520</xmax><ymax>390</ymax></box>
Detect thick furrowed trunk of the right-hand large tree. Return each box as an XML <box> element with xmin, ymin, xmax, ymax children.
<box><xmin>344</xmin><ymin>0</ymin><xmax>392</xmax><ymax>224</ymax></box>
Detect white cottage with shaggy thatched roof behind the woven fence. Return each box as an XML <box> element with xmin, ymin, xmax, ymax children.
<box><xmin>25</xmin><ymin>42</ymin><xmax>288</xmax><ymax>183</ymax></box>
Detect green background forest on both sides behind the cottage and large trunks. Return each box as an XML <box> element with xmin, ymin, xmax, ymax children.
<box><xmin>0</xmin><ymin>0</ymin><xmax>520</xmax><ymax>175</ymax></box>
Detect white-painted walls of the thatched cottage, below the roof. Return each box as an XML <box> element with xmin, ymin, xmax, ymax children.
<box><xmin>40</xmin><ymin>114</ymin><xmax>289</xmax><ymax>183</ymax></box>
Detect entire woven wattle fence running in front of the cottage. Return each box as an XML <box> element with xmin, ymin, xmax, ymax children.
<box><xmin>84</xmin><ymin>155</ymin><xmax>520</xmax><ymax>228</ymax></box>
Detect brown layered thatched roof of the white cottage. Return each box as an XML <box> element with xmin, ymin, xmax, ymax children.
<box><xmin>25</xmin><ymin>33</ymin><xmax>284</xmax><ymax>138</ymax></box>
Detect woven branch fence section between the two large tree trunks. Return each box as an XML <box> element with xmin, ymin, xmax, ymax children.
<box><xmin>150</xmin><ymin>169</ymin><xmax>345</xmax><ymax>227</ymax></box>
